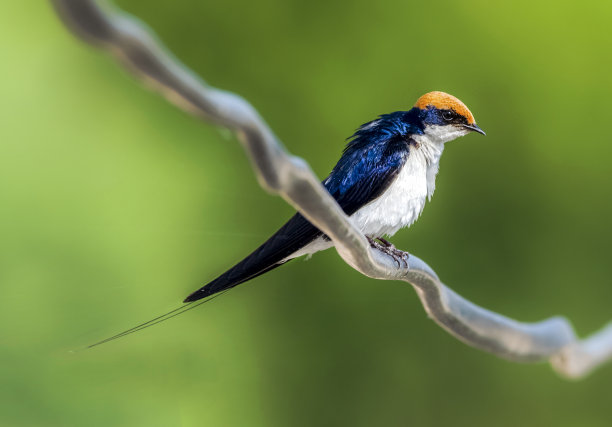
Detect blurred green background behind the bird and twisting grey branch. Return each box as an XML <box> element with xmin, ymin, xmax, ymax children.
<box><xmin>0</xmin><ymin>0</ymin><xmax>612</xmax><ymax>426</ymax></box>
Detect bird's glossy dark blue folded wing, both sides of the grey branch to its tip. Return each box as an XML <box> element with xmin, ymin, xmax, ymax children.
<box><xmin>185</xmin><ymin>116</ymin><xmax>410</xmax><ymax>302</ymax></box>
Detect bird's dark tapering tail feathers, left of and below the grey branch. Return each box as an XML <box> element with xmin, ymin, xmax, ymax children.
<box><xmin>184</xmin><ymin>214</ymin><xmax>322</xmax><ymax>302</ymax></box>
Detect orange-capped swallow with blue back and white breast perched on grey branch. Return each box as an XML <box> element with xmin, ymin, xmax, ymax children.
<box><xmin>183</xmin><ymin>91</ymin><xmax>485</xmax><ymax>303</ymax></box>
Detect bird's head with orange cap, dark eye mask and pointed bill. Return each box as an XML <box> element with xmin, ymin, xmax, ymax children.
<box><xmin>413</xmin><ymin>92</ymin><xmax>485</xmax><ymax>142</ymax></box>
